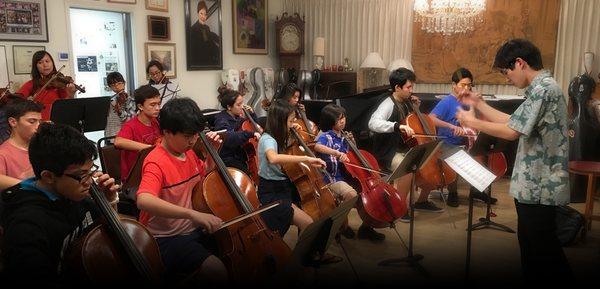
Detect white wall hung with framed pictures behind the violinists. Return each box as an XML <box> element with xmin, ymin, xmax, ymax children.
<box><xmin>0</xmin><ymin>0</ymin><xmax>283</xmax><ymax>108</ymax></box>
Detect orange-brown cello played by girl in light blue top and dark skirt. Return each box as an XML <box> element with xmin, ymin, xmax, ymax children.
<box><xmin>282</xmin><ymin>128</ymin><xmax>337</xmax><ymax>220</ymax></box>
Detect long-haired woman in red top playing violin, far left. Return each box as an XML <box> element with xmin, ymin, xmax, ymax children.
<box><xmin>17</xmin><ymin>50</ymin><xmax>77</xmax><ymax>120</ymax></box>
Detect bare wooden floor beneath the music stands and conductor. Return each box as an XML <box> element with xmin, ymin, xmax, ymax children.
<box><xmin>284</xmin><ymin>178</ymin><xmax>600</xmax><ymax>288</ymax></box>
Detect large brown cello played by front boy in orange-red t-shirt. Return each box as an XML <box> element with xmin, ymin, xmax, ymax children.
<box><xmin>192</xmin><ymin>132</ymin><xmax>292</xmax><ymax>283</ymax></box>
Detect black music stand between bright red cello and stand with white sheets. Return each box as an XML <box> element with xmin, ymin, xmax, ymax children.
<box><xmin>378</xmin><ymin>140</ymin><xmax>442</xmax><ymax>276</ymax></box>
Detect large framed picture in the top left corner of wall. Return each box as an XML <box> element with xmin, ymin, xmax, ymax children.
<box><xmin>0</xmin><ymin>0</ymin><xmax>48</xmax><ymax>42</ymax></box>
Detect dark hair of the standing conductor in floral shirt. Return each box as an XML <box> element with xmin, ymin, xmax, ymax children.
<box><xmin>492</xmin><ymin>39</ymin><xmax>544</xmax><ymax>70</ymax></box>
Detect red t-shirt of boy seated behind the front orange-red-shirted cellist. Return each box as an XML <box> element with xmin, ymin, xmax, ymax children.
<box><xmin>117</xmin><ymin>117</ymin><xmax>160</xmax><ymax>181</ymax></box>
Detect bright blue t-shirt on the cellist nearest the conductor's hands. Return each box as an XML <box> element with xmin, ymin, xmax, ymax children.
<box><xmin>431</xmin><ymin>94</ymin><xmax>469</xmax><ymax>145</ymax></box>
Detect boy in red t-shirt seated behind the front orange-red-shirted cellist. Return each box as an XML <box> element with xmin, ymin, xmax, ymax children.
<box><xmin>115</xmin><ymin>85</ymin><xmax>160</xmax><ymax>182</ymax></box>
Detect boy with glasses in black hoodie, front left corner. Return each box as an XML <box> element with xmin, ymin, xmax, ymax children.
<box><xmin>2</xmin><ymin>123</ymin><xmax>118</xmax><ymax>287</ymax></box>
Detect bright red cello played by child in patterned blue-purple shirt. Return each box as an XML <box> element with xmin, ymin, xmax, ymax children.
<box><xmin>342</xmin><ymin>132</ymin><xmax>406</xmax><ymax>228</ymax></box>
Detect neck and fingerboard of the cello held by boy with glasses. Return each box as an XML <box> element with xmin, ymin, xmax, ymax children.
<box><xmin>90</xmin><ymin>181</ymin><xmax>156</xmax><ymax>284</ymax></box>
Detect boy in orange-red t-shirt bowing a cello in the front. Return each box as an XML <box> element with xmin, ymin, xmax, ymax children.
<box><xmin>137</xmin><ymin>98</ymin><xmax>227</xmax><ymax>287</ymax></box>
